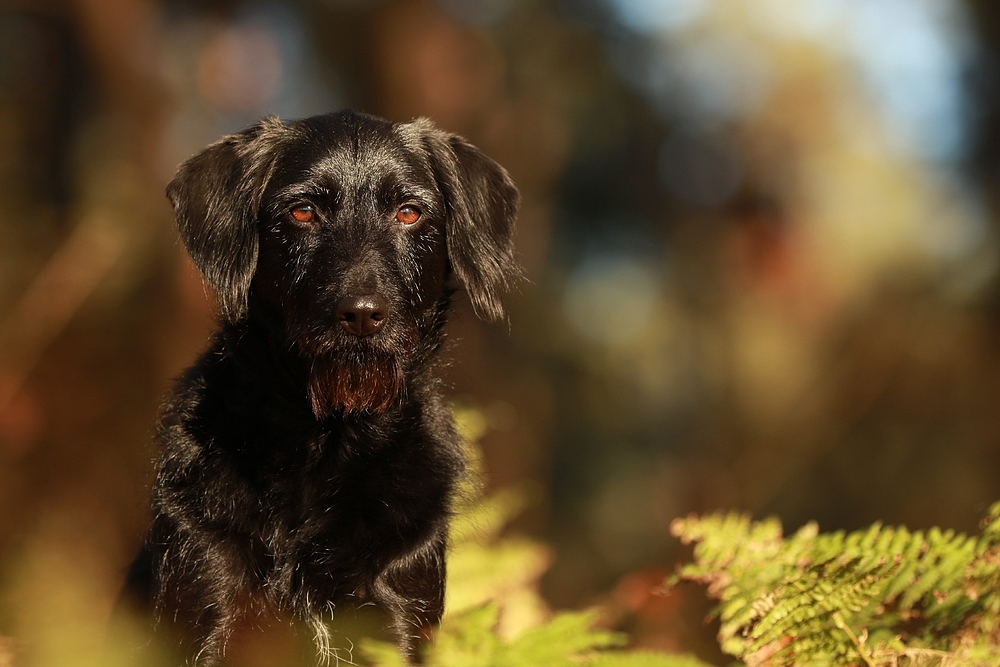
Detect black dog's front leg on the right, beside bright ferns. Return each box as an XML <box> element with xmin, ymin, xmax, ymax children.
<box><xmin>371</xmin><ymin>529</ymin><xmax>446</xmax><ymax>665</ymax></box>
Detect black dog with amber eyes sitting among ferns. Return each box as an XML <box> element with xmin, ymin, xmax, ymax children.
<box><xmin>126</xmin><ymin>111</ymin><xmax>518</xmax><ymax>664</ymax></box>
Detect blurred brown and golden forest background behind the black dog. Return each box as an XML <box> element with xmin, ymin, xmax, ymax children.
<box><xmin>0</xmin><ymin>0</ymin><xmax>1000</xmax><ymax>660</ymax></box>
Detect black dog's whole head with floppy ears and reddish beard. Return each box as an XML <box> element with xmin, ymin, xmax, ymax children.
<box><xmin>167</xmin><ymin>111</ymin><xmax>518</xmax><ymax>418</ymax></box>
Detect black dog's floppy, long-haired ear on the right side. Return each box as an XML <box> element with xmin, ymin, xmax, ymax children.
<box><xmin>412</xmin><ymin>118</ymin><xmax>521</xmax><ymax>321</ymax></box>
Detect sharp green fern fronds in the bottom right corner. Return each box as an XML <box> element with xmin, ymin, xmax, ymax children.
<box><xmin>668</xmin><ymin>503</ymin><xmax>1000</xmax><ymax>667</ymax></box>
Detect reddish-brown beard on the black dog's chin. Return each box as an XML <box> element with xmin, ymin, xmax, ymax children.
<box><xmin>309</xmin><ymin>356</ymin><xmax>405</xmax><ymax>419</ymax></box>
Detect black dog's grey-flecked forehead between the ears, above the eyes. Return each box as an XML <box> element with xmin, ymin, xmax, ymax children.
<box><xmin>276</xmin><ymin>114</ymin><xmax>432</xmax><ymax>190</ymax></box>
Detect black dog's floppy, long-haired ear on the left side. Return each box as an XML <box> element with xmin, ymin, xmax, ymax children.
<box><xmin>167</xmin><ymin>117</ymin><xmax>284</xmax><ymax>322</ymax></box>
